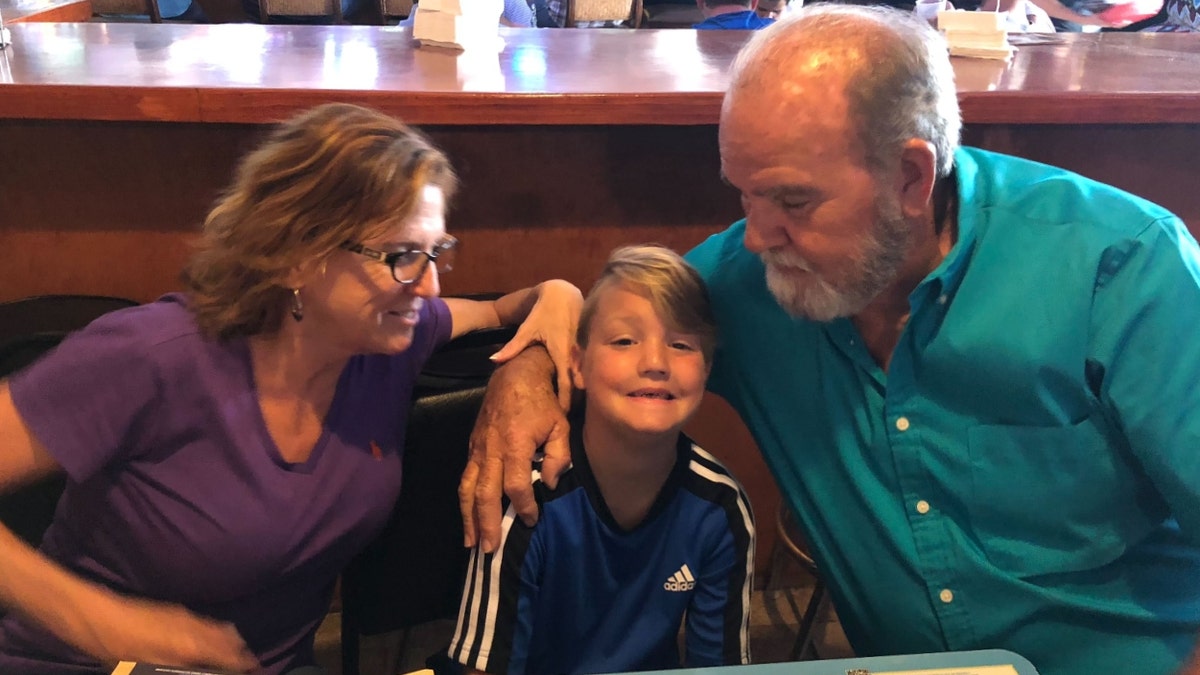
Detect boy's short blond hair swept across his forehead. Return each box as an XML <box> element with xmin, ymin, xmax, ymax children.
<box><xmin>575</xmin><ymin>244</ymin><xmax>716</xmax><ymax>363</ymax></box>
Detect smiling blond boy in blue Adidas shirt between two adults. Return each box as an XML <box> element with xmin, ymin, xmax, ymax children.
<box><xmin>450</xmin><ymin>246</ymin><xmax>755</xmax><ymax>675</ymax></box>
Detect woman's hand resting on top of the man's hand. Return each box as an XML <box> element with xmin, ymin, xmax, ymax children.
<box><xmin>487</xmin><ymin>279</ymin><xmax>583</xmax><ymax>410</ymax></box>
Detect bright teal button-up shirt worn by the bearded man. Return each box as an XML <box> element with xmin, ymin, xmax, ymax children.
<box><xmin>688</xmin><ymin>149</ymin><xmax>1200</xmax><ymax>675</ymax></box>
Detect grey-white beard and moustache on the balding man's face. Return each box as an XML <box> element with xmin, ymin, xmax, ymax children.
<box><xmin>760</xmin><ymin>196</ymin><xmax>911</xmax><ymax>322</ymax></box>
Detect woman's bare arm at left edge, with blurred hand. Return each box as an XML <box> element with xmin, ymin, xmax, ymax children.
<box><xmin>0</xmin><ymin>381</ymin><xmax>258</xmax><ymax>673</ymax></box>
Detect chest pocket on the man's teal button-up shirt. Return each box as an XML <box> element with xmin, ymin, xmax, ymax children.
<box><xmin>966</xmin><ymin>414</ymin><xmax>1154</xmax><ymax>577</ymax></box>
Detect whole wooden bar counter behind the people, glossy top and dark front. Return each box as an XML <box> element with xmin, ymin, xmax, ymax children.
<box><xmin>0</xmin><ymin>23</ymin><xmax>1200</xmax><ymax>567</ymax></box>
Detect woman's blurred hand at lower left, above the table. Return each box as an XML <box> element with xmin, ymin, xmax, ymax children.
<box><xmin>77</xmin><ymin>590</ymin><xmax>262</xmax><ymax>673</ymax></box>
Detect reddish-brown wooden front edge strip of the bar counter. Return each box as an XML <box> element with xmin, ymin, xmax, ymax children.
<box><xmin>7</xmin><ymin>84</ymin><xmax>1200</xmax><ymax>126</ymax></box>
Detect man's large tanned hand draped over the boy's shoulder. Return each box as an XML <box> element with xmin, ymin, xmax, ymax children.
<box><xmin>458</xmin><ymin>347</ymin><xmax>571</xmax><ymax>552</ymax></box>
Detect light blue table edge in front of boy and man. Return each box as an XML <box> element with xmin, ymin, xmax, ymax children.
<box><xmin>648</xmin><ymin>650</ymin><xmax>1038</xmax><ymax>675</ymax></box>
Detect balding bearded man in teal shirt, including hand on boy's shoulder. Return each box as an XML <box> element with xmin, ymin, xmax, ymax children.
<box><xmin>461</xmin><ymin>5</ymin><xmax>1200</xmax><ymax>675</ymax></box>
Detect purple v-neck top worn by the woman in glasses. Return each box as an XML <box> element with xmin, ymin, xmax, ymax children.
<box><xmin>0</xmin><ymin>294</ymin><xmax>450</xmax><ymax>675</ymax></box>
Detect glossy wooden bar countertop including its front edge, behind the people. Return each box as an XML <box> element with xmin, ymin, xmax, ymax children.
<box><xmin>0</xmin><ymin>23</ymin><xmax>1200</xmax><ymax>125</ymax></box>
